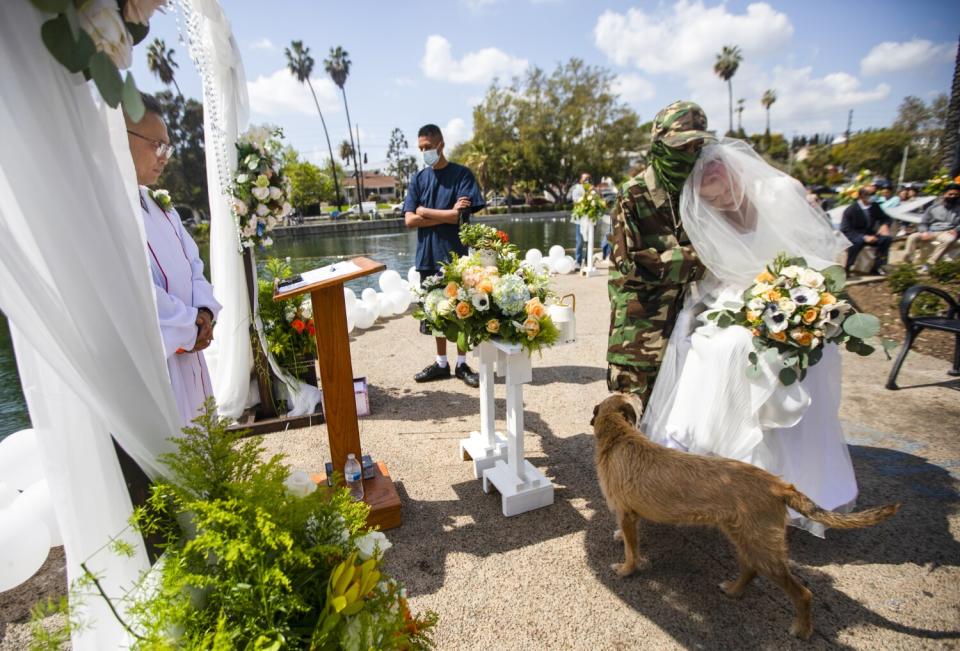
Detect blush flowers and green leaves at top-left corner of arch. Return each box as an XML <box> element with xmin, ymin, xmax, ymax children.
<box><xmin>31</xmin><ymin>0</ymin><xmax>167</xmax><ymax>122</ymax></box>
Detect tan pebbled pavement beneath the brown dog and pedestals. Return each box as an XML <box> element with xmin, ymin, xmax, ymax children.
<box><xmin>255</xmin><ymin>268</ymin><xmax>960</xmax><ymax>649</ymax></box>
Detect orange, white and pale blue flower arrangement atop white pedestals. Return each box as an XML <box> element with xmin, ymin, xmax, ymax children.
<box><xmin>413</xmin><ymin>225</ymin><xmax>559</xmax><ymax>352</ymax></box>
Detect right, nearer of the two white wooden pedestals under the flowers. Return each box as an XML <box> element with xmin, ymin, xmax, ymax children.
<box><xmin>474</xmin><ymin>342</ymin><xmax>553</xmax><ymax>517</ymax></box>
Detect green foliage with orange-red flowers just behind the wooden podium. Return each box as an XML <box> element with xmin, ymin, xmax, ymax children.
<box><xmin>258</xmin><ymin>258</ymin><xmax>317</xmax><ymax>384</ymax></box>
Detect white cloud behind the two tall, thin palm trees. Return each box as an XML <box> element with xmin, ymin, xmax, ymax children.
<box><xmin>247</xmin><ymin>68</ymin><xmax>340</xmax><ymax>117</ymax></box>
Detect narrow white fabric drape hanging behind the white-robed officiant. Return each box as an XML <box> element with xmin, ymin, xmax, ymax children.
<box><xmin>180</xmin><ymin>0</ymin><xmax>256</xmax><ymax>418</ymax></box>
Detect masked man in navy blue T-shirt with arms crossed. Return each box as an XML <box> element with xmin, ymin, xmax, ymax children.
<box><xmin>403</xmin><ymin>124</ymin><xmax>486</xmax><ymax>387</ymax></box>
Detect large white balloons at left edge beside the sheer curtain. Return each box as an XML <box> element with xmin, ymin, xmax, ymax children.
<box><xmin>0</xmin><ymin>429</ymin><xmax>63</xmax><ymax>592</ymax></box>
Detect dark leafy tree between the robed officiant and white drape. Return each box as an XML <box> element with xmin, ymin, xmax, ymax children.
<box><xmin>155</xmin><ymin>90</ymin><xmax>210</xmax><ymax>213</ymax></box>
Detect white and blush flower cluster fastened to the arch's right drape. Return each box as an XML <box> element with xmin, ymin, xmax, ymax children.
<box><xmin>228</xmin><ymin>127</ymin><xmax>293</xmax><ymax>247</ymax></box>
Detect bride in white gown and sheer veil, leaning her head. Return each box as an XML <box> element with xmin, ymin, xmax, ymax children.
<box><xmin>642</xmin><ymin>140</ymin><xmax>857</xmax><ymax>537</ymax></box>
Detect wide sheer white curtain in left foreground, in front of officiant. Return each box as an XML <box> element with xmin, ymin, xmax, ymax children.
<box><xmin>0</xmin><ymin>1</ymin><xmax>179</xmax><ymax>649</ymax></box>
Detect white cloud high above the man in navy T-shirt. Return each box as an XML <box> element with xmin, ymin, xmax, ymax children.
<box><xmin>420</xmin><ymin>34</ymin><xmax>527</xmax><ymax>84</ymax></box>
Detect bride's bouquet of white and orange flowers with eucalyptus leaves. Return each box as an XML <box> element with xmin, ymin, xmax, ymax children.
<box><xmin>707</xmin><ymin>254</ymin><xmax>886</xmax><ymax>385</ymax></box>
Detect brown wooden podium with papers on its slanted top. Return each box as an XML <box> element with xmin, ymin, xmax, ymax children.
<box><xmin>273</xmin><ymin>257</ymin><xmax>400</xmax><ymax>529</ymax></box>
